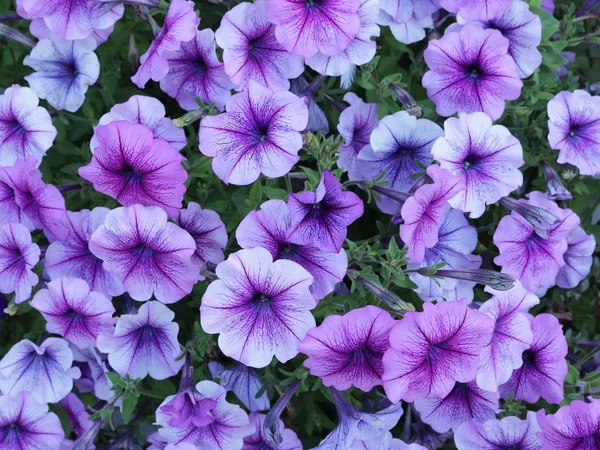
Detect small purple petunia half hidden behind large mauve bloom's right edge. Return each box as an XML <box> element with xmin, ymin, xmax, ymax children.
<box><xmin>175</xmin><ymin>202</ymin><xmax>227</xmax><ymax>279</ymax></box>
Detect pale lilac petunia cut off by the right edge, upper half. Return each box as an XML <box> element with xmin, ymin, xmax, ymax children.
<box><xmin>548</xmin><ymin>90</ymin><xmax>600</xmax><ymax>175</ymax></box>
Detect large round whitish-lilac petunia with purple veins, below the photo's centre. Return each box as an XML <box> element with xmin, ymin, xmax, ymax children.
<box><xmin>200</xmin><ymin>247</ymin><xmax>316</xmax><ymax>368</ymax></box>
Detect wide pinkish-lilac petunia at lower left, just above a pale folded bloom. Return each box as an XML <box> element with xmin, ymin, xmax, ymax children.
<box><xmin>30</xmin><ymin>278</ymin><xmax>116</xmax><ymax>348</ymax></box>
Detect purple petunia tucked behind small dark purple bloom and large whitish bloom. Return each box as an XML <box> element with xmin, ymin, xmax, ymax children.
<box><xmin>236</xmin><ymin>200</ymin><xmax>348</xmax><ymax>300</ymax></box>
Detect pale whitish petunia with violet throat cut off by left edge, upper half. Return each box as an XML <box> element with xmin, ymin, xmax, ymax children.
<box><xmin>0</xmin><ymin>84</ymin><xmax>57</xmax><ymax>166</ymax></box>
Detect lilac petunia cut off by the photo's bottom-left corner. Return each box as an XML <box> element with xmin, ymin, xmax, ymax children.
<box><xmin>0</xmin><ymin>391</ymin><xmax>65</xmax><ymax>450</ymax></box>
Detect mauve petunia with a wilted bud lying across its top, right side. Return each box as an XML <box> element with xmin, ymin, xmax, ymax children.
<box><xmin>494</xmin><ymin>191</ymin><xmax>579</xmax><ymax>292</ymax></box>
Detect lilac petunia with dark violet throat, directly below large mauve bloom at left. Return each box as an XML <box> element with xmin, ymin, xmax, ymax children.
<box><xmin>96</xmin><ymin>301</ymin><xmax>183</xmax><ymax>380</ymax></box>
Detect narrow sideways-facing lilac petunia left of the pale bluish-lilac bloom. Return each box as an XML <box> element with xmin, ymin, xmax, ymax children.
<box><xmin>337</xmin><ymin>92</ymin><xmax>379</xmax><ymax>180</ymax></box>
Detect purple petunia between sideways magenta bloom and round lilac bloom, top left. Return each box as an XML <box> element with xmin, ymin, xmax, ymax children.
<box><xmin>160</xmin><ymin>28</ymin><xmax>233</xmax><ymax>111</ymax></box>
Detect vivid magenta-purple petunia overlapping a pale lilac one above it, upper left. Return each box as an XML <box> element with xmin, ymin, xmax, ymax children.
<box><xmin>79</xmin><ymin>121</ymin><xmax>188</xmax><ymax>217</ymax></box>
